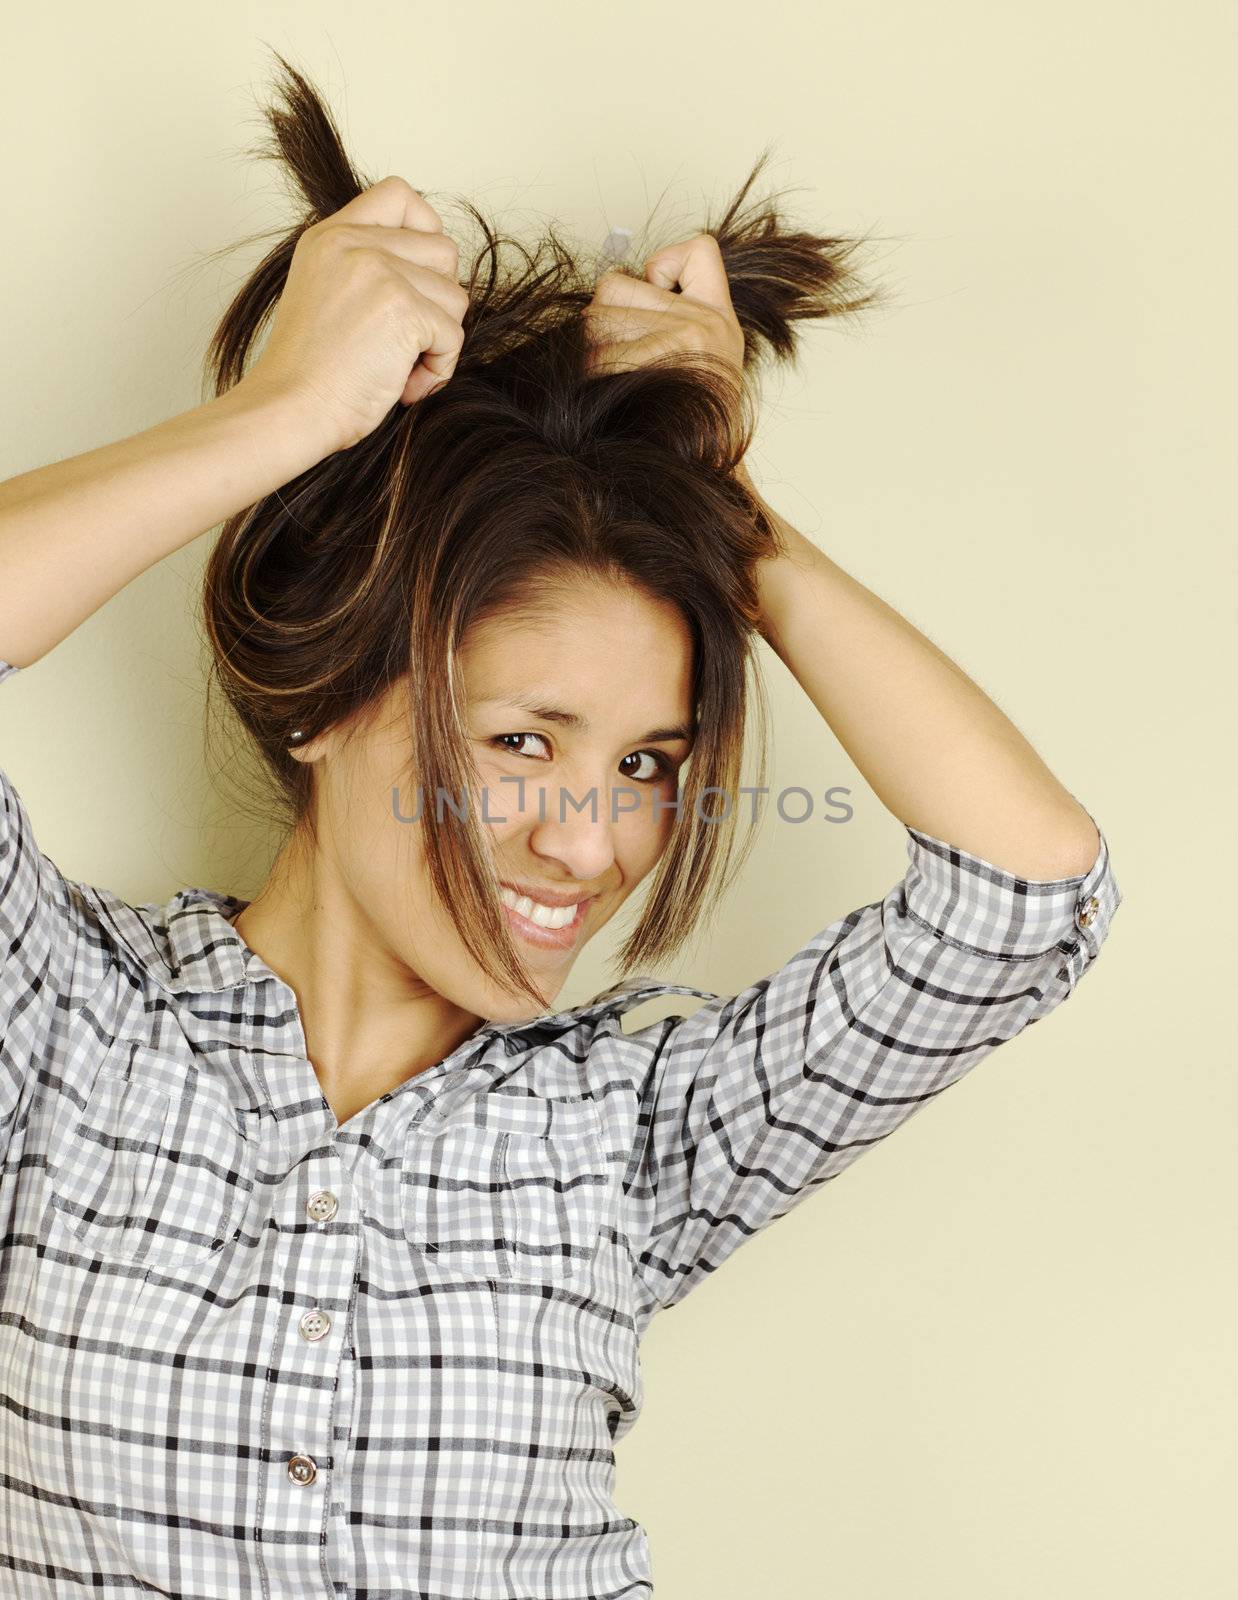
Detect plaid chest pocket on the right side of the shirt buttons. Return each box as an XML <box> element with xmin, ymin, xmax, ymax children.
<box><xmin>401</xmin><ymin>1090</ymin><xmax>609</xmax><ymax>1283</ymax></box>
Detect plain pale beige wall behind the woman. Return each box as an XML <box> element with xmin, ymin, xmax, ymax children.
<box><xmin>0</xmin><ymin>0</ymin><xmax>1238</xmax><ymax>1600</ymax></box>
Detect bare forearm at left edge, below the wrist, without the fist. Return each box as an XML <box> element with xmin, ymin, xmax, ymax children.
<box><xmin>0</xmin><ymin>382</ymin><xmax>326</xmax><ymax>667</ymax></box>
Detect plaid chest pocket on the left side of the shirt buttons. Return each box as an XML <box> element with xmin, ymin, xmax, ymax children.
<box><xmin>50</xmin><ymin>1045</ymin><xmax>258</xmax><ymax>1267</ymax></box>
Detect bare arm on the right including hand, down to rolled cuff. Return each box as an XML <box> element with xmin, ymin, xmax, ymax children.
<box><xmin>584</xmin><ymin>234</ymin><xmax>1102</xmax><ymax>880</ymax></box>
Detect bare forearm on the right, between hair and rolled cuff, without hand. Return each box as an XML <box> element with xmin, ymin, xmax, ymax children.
<box><xmin>741</xmin><ymin>467</ymin><xmax>1100</xmax><ymax>878</ymax></box>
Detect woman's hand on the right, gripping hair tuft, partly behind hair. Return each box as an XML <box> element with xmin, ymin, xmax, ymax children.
<box><xmin>581</xmin><ymin>234</ymin><xmax>744</xmax><ymax>425</ymax></box>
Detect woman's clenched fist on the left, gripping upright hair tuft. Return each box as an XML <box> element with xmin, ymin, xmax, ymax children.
<box><xmin>237</xmin><ymin>176</ymin><xmax>469</xmax><ymax>454</ymax></box>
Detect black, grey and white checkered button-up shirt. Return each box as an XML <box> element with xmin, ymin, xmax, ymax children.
<box><xmin>0</xmin><ymin>662</ymin><xmax>1120</xmax><ymax>1600</ymax></box>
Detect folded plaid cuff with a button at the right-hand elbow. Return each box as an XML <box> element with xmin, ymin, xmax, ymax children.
<box><xmin>904</xmin><ymin>808</ymin><xmax>1121</xmax><ymax>965</ymax></box>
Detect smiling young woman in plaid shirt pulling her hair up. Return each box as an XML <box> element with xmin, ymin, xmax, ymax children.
<box><xmin>0</xmin><ymin>62</ymin><xmax>1120</xmax><ymax>1600</ymax></box>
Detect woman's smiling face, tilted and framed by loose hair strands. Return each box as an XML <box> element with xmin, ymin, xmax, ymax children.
<box><xmin>299</xmin><ymin>579</ymin><xmax>693</xmax><ymax>1021</ymax></box>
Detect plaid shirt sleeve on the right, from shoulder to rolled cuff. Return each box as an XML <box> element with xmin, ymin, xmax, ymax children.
<box><xmin>625</xmin><ymin>806</ymin><xmax>1121</xmax><ymax>1320</ymax></box>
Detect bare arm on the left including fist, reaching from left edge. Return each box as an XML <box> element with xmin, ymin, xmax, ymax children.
<box><xmin>0</xmin><ymin>176</ymin><xmax>469</xmax><ymax>667</ymax></box>
